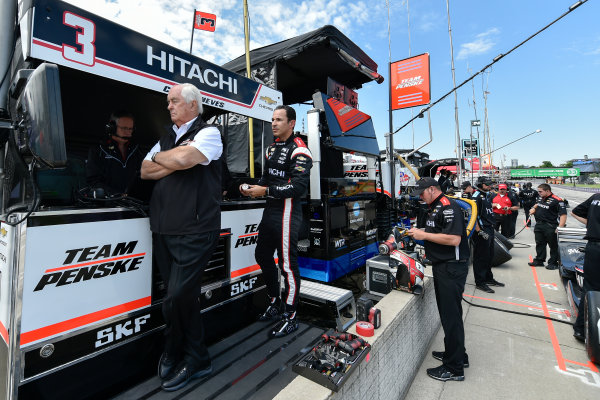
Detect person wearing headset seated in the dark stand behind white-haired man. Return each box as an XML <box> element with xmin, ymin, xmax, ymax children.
<box><xmin>85</xmin><ymin>110</ymin><xmax>147</xmax><ymax>195</ymax></box>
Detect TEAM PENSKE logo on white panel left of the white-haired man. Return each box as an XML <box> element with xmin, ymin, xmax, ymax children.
<box><xmin>33</xmin><ymin>240</ymin><xmax>146</xmax><ymax>292</ymax></box>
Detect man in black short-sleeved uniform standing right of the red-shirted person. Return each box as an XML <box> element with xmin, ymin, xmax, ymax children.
<box><xmin>528</xmin><ymin>183</ymin><xmax>567</xmax><ymax>269</ymax></box>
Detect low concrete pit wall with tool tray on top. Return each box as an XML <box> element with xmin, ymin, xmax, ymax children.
<box><xmin>275</xmin><ymin>278</ymin><xmax>440</xmax><ymax>400</ymax></box>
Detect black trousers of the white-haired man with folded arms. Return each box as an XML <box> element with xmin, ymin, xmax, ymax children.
<box><xmin>152</xmin><ymin>231</ymin><xmax>219</xmax><ymax>368</ymax></box>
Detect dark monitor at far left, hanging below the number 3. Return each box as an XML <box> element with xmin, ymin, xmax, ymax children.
<box><xmin>17</xmin><ymin>63</ymin><xmax>67</xmax><ymax>168</ymax></box>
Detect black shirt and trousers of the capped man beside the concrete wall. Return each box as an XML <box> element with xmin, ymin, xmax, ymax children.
<box><xmin>425</xmin><ymin>194</ymin><xmax>469</xmax><ymax>375</ymax></box>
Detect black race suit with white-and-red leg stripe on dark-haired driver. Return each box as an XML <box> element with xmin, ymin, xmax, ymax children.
<box><xmin>255</xmin><ymin>135</ymin><xmax>312</xmax><ymax>313</ymax></box>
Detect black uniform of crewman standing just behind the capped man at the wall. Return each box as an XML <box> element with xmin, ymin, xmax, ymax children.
<box><xmin>471</xmin><ymin>189</ymin><xmax>496</xmax><ymax>285</ymax></box>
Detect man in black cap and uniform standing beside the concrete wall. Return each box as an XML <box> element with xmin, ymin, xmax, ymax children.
<box><xmin>408</xmin><ymin>178</ymin><xmax>469</xmax><ymax>381</ymax></box>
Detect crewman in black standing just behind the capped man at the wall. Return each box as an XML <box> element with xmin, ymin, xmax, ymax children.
<box><xmin>472</xmin><ymin>176</ymin><xmax>504</xmax><ymax>293</ymax></box>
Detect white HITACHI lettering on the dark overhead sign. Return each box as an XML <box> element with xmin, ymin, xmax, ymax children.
<box><xmin>146</xmin><ymin>45</ymin><xmax>237</xmax><ymax>94</ymax></box>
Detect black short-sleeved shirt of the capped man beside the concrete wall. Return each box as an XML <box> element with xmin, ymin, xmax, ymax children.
<box><xmin>425</xmin><ymin>194</ymin><xmax>469</xmax><ymax>264</ymax></box>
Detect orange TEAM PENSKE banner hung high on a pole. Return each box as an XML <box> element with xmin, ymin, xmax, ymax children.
<box><xmin>390</xmin><ymin>53</ymin><xmax>431</xmax><ymax>110</ymax></box>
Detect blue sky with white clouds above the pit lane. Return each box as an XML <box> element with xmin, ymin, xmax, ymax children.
<box><xmin>63</xmin><ymin>0</ymin><xmax>600</xmax><ymax>165</ymax></box>
